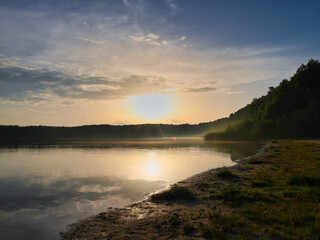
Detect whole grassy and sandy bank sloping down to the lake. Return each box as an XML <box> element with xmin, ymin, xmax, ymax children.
<box><xmin>63</xmin><ymin>141</ymin><xmax>320</xmax><ymax>239</ymax></box>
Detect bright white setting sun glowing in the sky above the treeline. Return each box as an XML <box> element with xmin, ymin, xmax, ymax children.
<box><xmin>130</xmin><ymin>94</ymin><xmax>172</xmax><ymax>120</ymax></box>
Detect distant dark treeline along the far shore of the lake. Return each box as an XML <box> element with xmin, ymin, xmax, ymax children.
<box><xmin>0</xmin><ymin>122</ymin><xmax>218</xmax><ymax>145</ymax></box>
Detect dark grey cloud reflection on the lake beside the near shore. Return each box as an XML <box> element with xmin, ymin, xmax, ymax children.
<box><xmin>0</xmin><ymin>176</ymin><xmax>166</xmax><ymax>239</ymax></box>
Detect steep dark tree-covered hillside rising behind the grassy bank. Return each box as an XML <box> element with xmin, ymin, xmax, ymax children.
<box><xmin>205</xmin><ymin>59</ymin><xmax>320</xmax><ymax>140</ymax></box>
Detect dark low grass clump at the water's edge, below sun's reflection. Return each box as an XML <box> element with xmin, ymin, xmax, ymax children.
<box><xmin>151</xmin><ymin>185</ymin><xmax>196</xmax><ymax>202</ymax></box>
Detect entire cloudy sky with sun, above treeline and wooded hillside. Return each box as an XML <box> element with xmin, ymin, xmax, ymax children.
<box><xmin>0</xmin><ymin>0</ymin><xmax>320</xmax><ymax>126</ymax></box>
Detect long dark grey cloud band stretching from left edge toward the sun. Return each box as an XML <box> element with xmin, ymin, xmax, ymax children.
<box><xmin>0</xmin><ymin>65</ymin><xmax>168</xmax><ymax>102</ymax></box>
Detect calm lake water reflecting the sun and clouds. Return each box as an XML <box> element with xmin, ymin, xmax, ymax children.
<box><xmin>0</xmin><ymin>139</ymin><xmax>260</xmax><ymax>239</ymax></box>
